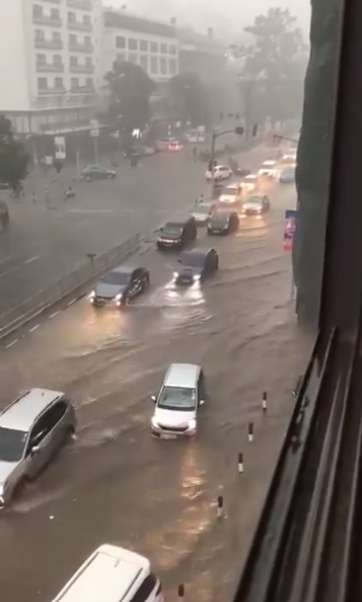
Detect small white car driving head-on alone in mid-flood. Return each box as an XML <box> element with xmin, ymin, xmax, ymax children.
<box><xmin>151</xmin><ymin>364</ymin><xmax>205</xmax><ymax>439</ymax></box>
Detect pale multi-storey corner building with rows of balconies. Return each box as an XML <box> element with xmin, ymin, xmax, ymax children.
<box><xmin>0</xmin><ymin>0</ymin><xmax>102</xmax><ymax>136</ymax></box>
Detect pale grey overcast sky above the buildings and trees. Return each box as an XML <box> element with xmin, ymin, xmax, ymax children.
<box><xmin>102</xmin><ymin>0</ymin><xmax>310</xmax><ymax>34</ymax></box>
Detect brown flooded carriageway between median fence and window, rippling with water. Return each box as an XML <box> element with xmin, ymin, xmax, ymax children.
<box><xmin>0</xmin><ymin>182</ymin><xmax>310</xmax><ymax>602</ymax></box>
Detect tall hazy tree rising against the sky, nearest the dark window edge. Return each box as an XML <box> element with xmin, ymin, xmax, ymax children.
<box><xmin>239</xmin><ymin>8</ymin><xmax>307</xmax><ymax>123</ymax></box>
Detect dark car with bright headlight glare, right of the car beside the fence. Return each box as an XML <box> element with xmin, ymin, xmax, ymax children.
<box><xmin>174</xmin><ymin>249</ymin><xmax>219</xmax><ymax>285</ymax></box>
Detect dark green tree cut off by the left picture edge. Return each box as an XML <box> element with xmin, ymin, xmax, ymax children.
<box><xmin>0</xmin><ymin>115</ymin><xmax>30</xmax><ymax>191</ymax></box>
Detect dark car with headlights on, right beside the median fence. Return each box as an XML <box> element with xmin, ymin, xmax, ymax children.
<box><xmin>89</xmin><ymin>266</ymin><xmax>150</xmax><ymax>307</ymax></box>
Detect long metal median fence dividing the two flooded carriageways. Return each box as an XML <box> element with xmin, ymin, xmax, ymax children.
<box><xmin>0</xmin><ymin>234</ymin><xmax>141</xmax><ymax>340</ymax></box>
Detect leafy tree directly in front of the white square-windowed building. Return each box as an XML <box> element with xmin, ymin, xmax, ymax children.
<box><xmin>105</xmin><ymin>61</ymin><xmax>155</xmax><ymax>135</ymax></box>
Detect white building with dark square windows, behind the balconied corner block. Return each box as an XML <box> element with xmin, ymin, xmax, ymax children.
<box><xmin>101</xmin><ymin>9</ymin><xmax>179</xmax><ymax>85</ymax></box>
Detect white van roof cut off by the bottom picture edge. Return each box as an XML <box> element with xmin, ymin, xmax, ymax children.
<box><xmin>53</xmin><ymin>544</ymin><xmax>164</xmax><ymax>602</ymax></box>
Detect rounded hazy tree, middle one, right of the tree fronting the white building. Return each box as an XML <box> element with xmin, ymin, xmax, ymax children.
<box><xmin>169</xmin><ymin>72</ymin><xmax>210</xmax><ymax>127</ymax></box>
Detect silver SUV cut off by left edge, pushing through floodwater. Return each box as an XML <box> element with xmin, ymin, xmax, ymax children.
<box><xmin>0</xmin><ymin>389</ymin><xmax>76</xmax><ymax>508</ymax></box>
